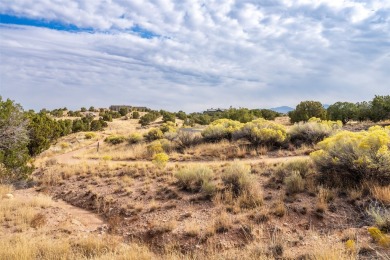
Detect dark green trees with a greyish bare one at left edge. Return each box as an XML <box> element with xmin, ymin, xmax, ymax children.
<box><xmin>0</xmin><ymin>96</ymin><xmax>107</xmax><ymax>181</ymax></box>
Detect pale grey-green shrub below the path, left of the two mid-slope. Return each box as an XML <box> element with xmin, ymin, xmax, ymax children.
<box><xmin>175</xmin><ymin>165</ymin><xmax>215</xmax><ymax>193</ymax></box>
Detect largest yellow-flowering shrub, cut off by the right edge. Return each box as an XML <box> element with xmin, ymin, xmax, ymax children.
<box><xmin>310</xmin><ymin>126</ymin><xmax>390</xmax><ymax>186</ymax></box>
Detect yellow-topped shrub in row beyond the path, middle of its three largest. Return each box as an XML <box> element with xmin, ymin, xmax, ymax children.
<box><xmin>234</xmin><ymin>119</ymin><xmax>287</xmax><ymax>147</ymax></box>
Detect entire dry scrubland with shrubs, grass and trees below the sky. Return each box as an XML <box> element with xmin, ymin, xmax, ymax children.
<box><xmin>0</xmin><ymin>96</ymin><xmax>390</xmax><ymax>259</ymax></box>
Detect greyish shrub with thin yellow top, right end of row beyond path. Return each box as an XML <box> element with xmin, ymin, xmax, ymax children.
<box><xmin>288</xmin><ymin>118</ymin><xmax>342</xmax><ymax>145</ymax></box>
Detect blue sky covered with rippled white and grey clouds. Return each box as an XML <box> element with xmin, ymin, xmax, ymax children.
<box><xmin>0</xmin><ymin>0</ymin><xmax>390</xmax><ymax>112</ymax></box>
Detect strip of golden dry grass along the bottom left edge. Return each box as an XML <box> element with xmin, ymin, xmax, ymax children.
<box><xmin>0</xmin><ymin>234</ymin><xmax>155</xmax><ymax>260</ymax></box>
